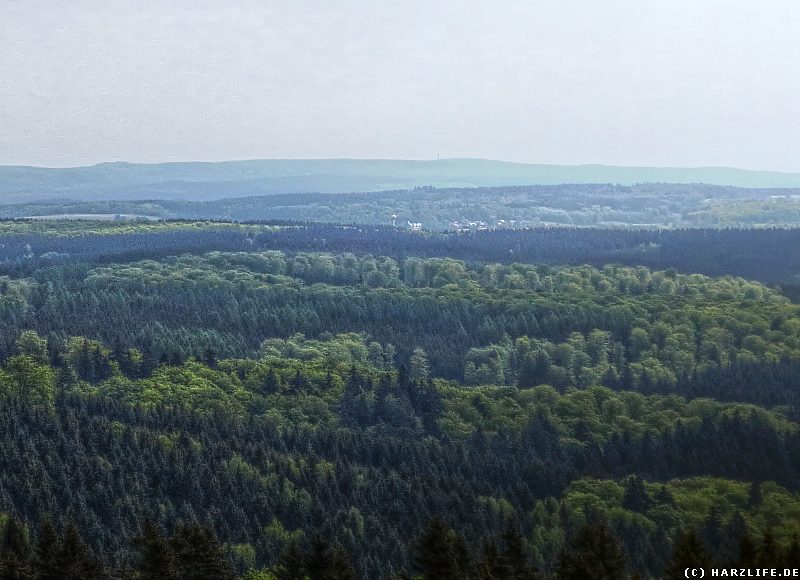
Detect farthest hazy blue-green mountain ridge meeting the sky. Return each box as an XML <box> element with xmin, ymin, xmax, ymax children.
<box><xmin>0</xmin><ymin>159</ymin><xmax>800</xmax><ymax>203</ymax></box>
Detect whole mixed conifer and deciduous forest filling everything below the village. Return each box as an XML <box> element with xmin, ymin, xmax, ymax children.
<box><xmin>0</xmin><ymin>221</ymin><xmax>800</xmax><ymax>580</ymax></box>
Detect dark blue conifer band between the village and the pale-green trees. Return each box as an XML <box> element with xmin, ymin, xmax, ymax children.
<box><xmin>0</xmin><ymin>220</ymin><xmax>800</xmax><ymax>286</ymax></box>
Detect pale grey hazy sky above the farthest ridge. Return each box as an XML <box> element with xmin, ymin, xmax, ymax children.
<box><xmin>0</xmin><ymin>0</ymin><xmax>800</xmax><ymax>171</ymax></box>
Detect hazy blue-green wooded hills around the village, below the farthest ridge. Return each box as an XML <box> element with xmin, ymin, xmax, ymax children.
<box><xmin>0</xmin><ymin>183</ymin><xmax>800</xmax><ymax>231</ymax></box>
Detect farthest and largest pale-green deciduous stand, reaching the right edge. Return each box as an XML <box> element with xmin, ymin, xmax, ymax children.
<box><xmin>78</xmin><ymin>251</ymin><xmax>800</xmax><ymax>389</ymax></box>
